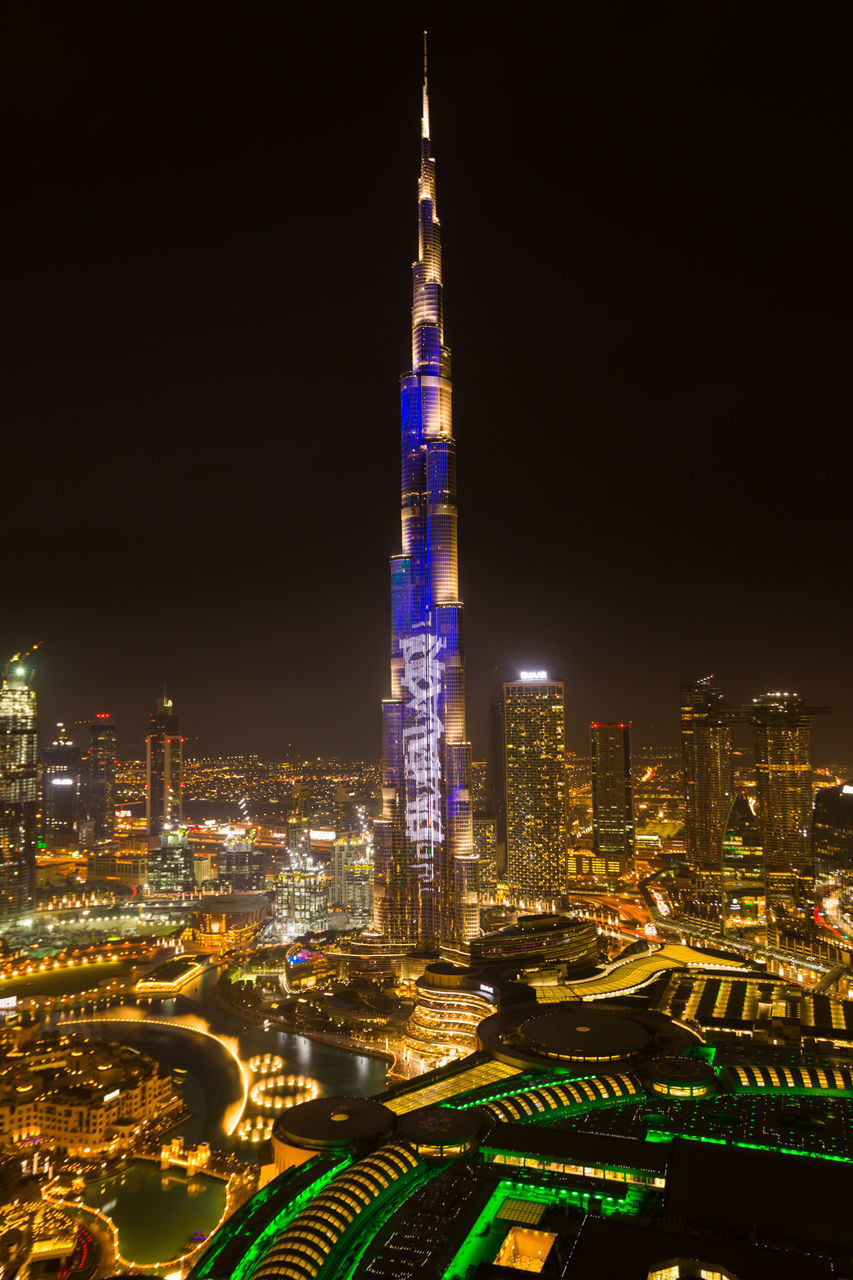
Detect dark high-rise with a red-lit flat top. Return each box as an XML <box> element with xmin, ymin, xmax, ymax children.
<box><xmin>589</xmin><ymin>721</ymin><xmax>634</xmax><ymax>872</ymax></box>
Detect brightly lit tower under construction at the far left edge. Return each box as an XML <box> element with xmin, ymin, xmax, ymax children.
<box><xmin>0</xmin><ymin>654</ymin><xmax>40</xmax><ymax>920</ymax></box>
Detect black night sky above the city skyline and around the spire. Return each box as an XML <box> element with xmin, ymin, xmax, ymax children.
<box><xmin>0</xmin><ymin>0</ymin><xmax>853</xmax><ymax>760</ymax></box>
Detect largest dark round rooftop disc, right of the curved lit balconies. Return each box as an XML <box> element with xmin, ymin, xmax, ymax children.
<box><xmin>520</xmin><ymin>1004</ymin><xmax>651</xmax><ymax>1062</ymax></box>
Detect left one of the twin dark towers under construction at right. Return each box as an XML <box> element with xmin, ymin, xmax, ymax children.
<box><xmin>681</xmin><ymin>676</ymin><xmax>734</xmax><ymax>878</ymax></box>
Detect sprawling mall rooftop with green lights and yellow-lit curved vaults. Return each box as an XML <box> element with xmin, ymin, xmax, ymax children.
<box><xmin>185</xmin><ymin>967</ymin><xmax>853</xmax><ymax>1280</ymax></box>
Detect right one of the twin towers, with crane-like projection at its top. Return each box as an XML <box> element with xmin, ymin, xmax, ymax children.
<box><xmin>749</xmin><ymin>692</ymin><xmax>827</xmax><ymax>905</ymax></box>
